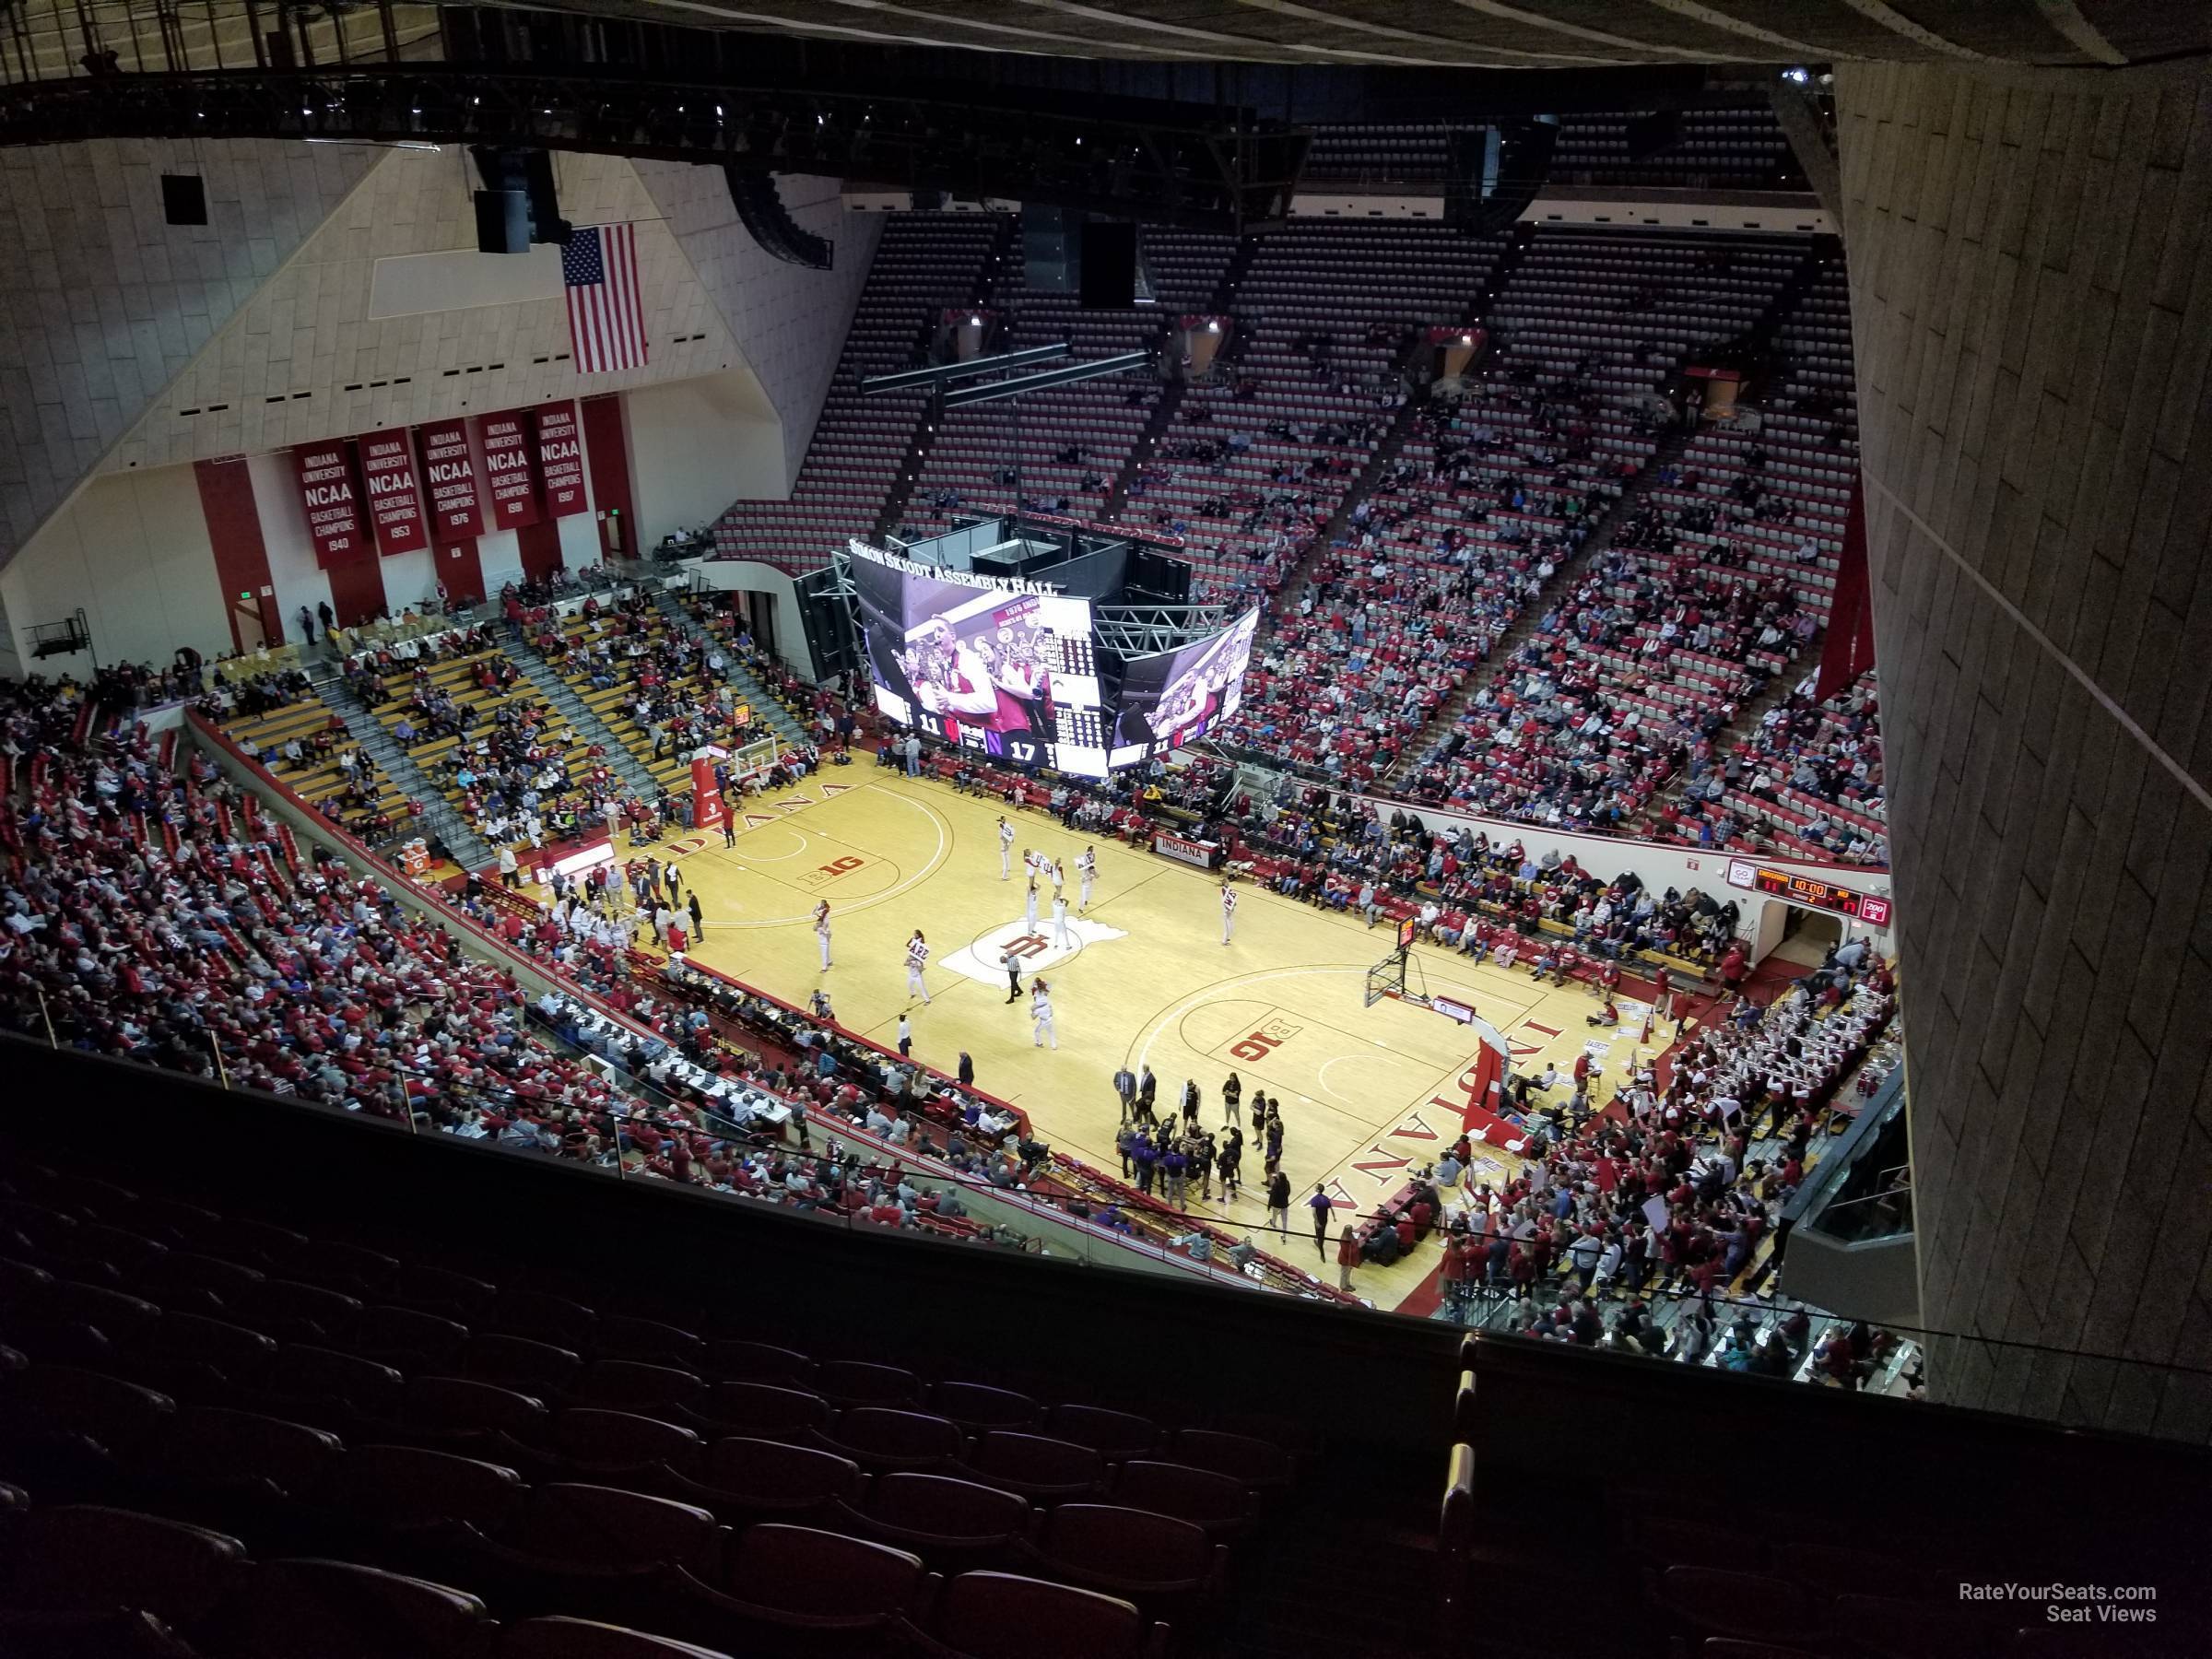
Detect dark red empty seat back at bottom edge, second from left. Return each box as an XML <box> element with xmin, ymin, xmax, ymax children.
<box><xmin>215</xmin><ymin>1559</ymin><xmax>485</xmax><ymax>1659</ymax></box>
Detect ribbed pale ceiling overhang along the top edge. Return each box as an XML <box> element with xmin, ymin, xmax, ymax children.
<box><xmin>533</xmin><ymin>0</ymin><xmax>2212</xmax><ymax>68</ymax></box>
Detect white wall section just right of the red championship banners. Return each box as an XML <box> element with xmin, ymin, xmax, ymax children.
<box><xmin>623</xmin><ymin>370</ymin><xmax>790</xmax><ymax>546</ymax></box>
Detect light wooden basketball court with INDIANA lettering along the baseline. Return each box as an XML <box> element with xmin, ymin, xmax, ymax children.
<box><xmin>637</xmin><ymin>761</ymin><xmax>1643</xmax><ymax>1307</ymax></box>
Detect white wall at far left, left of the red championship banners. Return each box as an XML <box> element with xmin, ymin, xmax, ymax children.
<box><xmin>0</xmin><ymin>466</ymin><xmax>228</xmax><ymax>675</ymax></box>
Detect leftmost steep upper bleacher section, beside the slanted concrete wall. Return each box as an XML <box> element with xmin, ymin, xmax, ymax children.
<box><xmin>714</xmin><ymin>212</ymin><xmax>1005</xmax><ymax>571</ymax></box>
